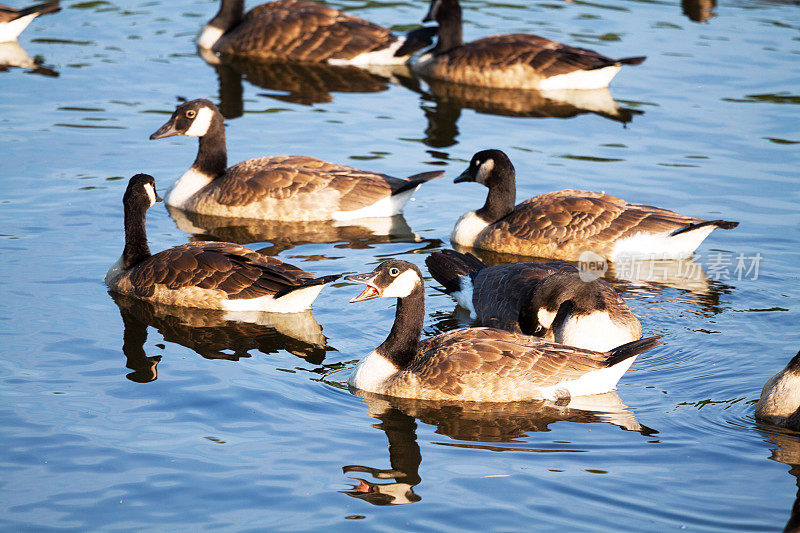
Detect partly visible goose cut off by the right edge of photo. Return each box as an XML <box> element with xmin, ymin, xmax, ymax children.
<box><xmin>755</xmin><ymin>352</ymin><xmax>800</xmax><ymax>431</ymax></box>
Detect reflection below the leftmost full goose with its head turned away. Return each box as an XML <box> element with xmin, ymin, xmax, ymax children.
<box><xmin>109</xmin><ymin>292</ymin><xmax>333</xmax><ymax>383</ymax></box>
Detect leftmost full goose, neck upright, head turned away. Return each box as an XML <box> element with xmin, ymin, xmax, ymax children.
<box><xmin>106</xmin><ymin>174</ymin><xmax>339</xmax><ymax>313</ymax></box>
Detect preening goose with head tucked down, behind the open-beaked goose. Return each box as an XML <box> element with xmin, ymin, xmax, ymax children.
<box><xmin>425</xmin><ymin>250</ymin><xmax>642</xmax><ymax>351</ymax></box>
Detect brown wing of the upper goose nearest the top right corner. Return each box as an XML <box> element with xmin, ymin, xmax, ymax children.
<box><xmin>447</xmin><ymin>33</ymin><xmax>615</xmax><ymax>77</ymax></box>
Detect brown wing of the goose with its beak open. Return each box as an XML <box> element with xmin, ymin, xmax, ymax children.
<box><xmin>407</xmin><ymin>328</ymin><xmax>608</xmax><ymax>395</ymax></box>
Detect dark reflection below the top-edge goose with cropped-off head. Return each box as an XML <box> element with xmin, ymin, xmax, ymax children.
<box><xmin>200</xmin><ymin>51</ymin><xmax>409</xmax><ymax>119</ymax></box>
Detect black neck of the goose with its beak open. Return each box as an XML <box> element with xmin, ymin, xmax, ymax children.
<box><xmin>376</xmin><ymin>283</ymin><xmax>425</xmax><ymax>369</ymax></box>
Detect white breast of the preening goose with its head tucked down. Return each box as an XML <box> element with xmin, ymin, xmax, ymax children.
<box><xmin>553</xmin><ymin>311</ymin><xmax>639</xmax><ymax>352</ymax></box>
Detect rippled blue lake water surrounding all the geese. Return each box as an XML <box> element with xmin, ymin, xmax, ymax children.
<box><xmin>0</xmin><ymin>0</ymin><xmax>800</xmax><ymax>531</ymax></box>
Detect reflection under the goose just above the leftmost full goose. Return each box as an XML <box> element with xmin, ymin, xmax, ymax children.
<box><xmin>167</xmin><ymin>206</ymin><xmax>441</xmax><ymax>255</ymax></box>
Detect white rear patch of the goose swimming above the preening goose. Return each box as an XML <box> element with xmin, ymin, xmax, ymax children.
<box><xmin>611</xmin><ymin>225</ymin><xmax>717</xmax><ymax>260</ymax></box>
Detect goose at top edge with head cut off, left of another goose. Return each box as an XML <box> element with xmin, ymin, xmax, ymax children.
<box><xmin>197</xmin><ymin>0</ymin><xmax>432</xmax><ymax>65</ymax></box>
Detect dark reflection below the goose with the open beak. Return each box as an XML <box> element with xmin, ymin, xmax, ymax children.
<box><xmin>342</xmin><ymin>391</ymin><xmax>658</xmax><ymax>505</ymax></box>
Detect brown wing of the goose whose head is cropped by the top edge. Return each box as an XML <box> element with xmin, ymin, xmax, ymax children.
<box><xmin>218</xmin><ymin>0</ymin><xmax>397</xmax><ymax>61</ymax></box>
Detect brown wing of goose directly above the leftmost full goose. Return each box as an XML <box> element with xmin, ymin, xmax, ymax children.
<box><xmin>214</xmin><ymin>156</ymin><xmax>406</xmax><ymax>211</ymax></box>
